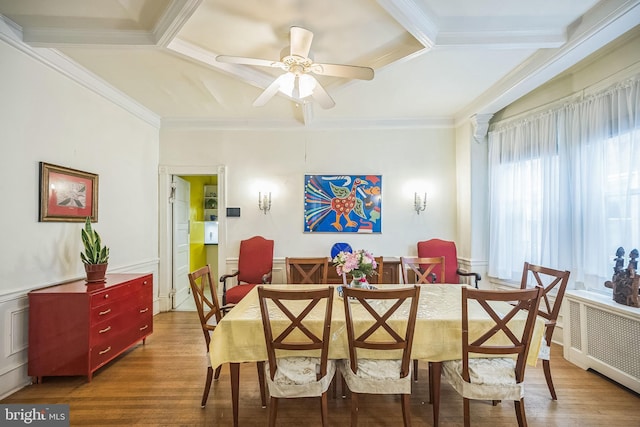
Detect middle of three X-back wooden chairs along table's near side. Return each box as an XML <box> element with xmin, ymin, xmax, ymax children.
<box><xmin>339</xmin><ymin>285</ymin><xmax>420</xmax><ymax>427</ymax></box>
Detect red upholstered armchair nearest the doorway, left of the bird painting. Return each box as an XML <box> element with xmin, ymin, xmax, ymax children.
<box><xmin>220</xmin><ymin>236</ymin><xmax>273</xmax><ymax>305</ymax></box>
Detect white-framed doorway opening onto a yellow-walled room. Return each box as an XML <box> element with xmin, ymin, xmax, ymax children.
<box><xmin>158</xmin><ymin>166</ymin><xmax>226</xmax><ymax>311</ymax></box>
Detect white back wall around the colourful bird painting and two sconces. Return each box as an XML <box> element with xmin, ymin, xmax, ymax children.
<box><xmin>160</xmin><ymin>125</ymin><xmax>456</xmax><ymax>262</ymax></box>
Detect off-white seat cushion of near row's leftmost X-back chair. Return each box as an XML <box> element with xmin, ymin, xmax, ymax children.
<box><xmin>264</xmin><ymin>357</ymin><xmax>336</xmax><ymax>397</ymax></box>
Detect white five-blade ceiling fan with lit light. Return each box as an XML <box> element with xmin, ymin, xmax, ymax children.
<box><xmin>216</xmin><ymin>27</ymin><xmax>373</xmax><ymax>108</ymax></box>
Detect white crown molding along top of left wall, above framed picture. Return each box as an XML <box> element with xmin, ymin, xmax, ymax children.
<box><xmin>0</xmin><ymin>15</ymin><xmax>160</xmax><ymax>128</ymax></box>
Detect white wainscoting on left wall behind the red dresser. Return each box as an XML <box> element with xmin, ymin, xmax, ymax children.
<box><xmin>0</xmin><ymin>260</ymin><xmax>159</xmax><ymax>399</ymax></box>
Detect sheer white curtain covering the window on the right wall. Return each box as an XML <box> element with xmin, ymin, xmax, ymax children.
<box><xmin>489</xmin><ymin>76</ymin><xmax>640</xmax><ymax>289</ymax></box>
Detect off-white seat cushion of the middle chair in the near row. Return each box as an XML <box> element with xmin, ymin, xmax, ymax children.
<box><xmin>338</xmin><ymin>359</ymin><xmax>411</xmax><ymax>394</ymax></box>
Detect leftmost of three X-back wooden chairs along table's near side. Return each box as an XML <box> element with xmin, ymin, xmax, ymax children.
<box><xmin>258</xmin><ymin>286</ymin><xmax>336</xmax><ymax>427</ymax></box>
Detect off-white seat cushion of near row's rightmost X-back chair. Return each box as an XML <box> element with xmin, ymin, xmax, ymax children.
<box><xmin>442</xmin><ymin>357</ymin><xmax>524</xmax><ymax>400</ymax></box>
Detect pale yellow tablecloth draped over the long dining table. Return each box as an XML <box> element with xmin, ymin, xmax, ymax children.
<box><xmin>210</xmin><ymin>284</ymin><xmax>544</xmax><ymax>368</ymax></box>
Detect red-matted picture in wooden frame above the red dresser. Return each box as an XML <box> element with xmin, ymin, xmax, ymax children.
<box><xmin>40</xmin><ymin>162</ymin><xmax>98</xmax><ymax>222</ymax></box>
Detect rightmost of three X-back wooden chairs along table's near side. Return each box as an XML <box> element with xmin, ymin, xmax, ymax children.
<box><xmin>430</xmin><ymin>287</ymin><xmax>543</xmax><ymax>427</ymax></box>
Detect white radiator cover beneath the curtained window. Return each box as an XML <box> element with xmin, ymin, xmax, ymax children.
<box><xmin>563</xmin><ymin>291</ymin><xmax>640</xmax><ymax>393</ymax></box>
